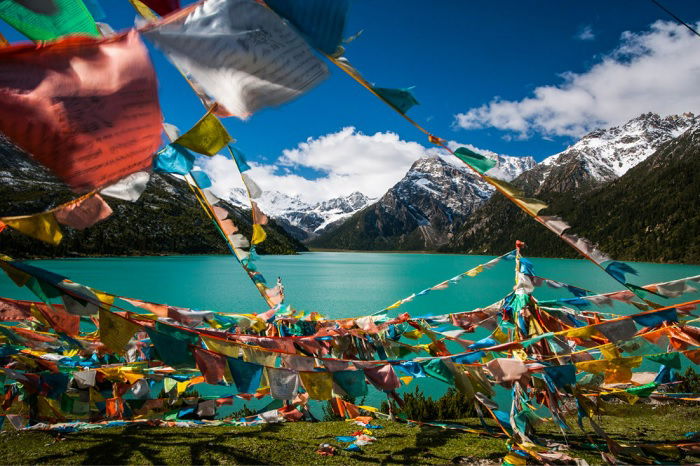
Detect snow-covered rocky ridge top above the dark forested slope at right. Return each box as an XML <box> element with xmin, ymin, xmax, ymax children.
<box><xmin>522</xmin><ymin>113</ymin><xmax>697</xmax><ymax>194</ymax></box>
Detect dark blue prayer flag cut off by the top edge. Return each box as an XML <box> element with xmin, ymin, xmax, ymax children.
<box><xmin>265</xmin><ymin>0</ymin><xmax>350</xmax><ymax>55</ymax></box>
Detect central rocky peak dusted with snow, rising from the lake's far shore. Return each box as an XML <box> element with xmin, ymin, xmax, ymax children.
<box><xmin>309</xmin><ymin>156</ymin><xmax>534</xmax><ymax>250</ymax></box>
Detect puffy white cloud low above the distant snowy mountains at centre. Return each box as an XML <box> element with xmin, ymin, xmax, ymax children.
<box><xmin>197</xmin><ymin>127</ymin><xmax>426</xmax><ymax>203</ymax></box>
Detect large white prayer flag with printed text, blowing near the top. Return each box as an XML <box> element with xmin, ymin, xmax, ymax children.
<box><xmin>143</xmin><ymin>0</ymin><xmax>328</xmax><ymax>119</ymax></box>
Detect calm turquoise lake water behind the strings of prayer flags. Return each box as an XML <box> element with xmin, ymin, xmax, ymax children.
<box><xmin>0</xmin><ymin>252</ymin><xmax>700</xmax><ymax>416</ymax></box>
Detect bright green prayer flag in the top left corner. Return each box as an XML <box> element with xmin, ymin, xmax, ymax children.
<box><xmin>0</xmin><ymin>0</ymin><xmax>100</xmax><ymax>41</ymax></box>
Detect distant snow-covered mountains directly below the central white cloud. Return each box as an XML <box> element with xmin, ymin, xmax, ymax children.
<box><xmin>229</xmin><ymin>189</ymin><xmax>376</xmax><ymax>241</ymax></box>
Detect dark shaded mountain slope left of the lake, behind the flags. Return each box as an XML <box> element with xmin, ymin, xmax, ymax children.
<box><xmin>0</xmin><ymin>138</ymin><xmax>306</xmax><ymax>258</ymax></box>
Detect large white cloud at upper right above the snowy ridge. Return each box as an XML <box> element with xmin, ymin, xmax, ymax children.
<box><xmin>455</xmin><ymin>21</ymin><xmax>700</xmax><ymax>138</ymax></box>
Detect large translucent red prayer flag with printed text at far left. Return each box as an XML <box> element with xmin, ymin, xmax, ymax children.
<box><xmin>0</xmin><ymin>31</ymin><xmax>162</xmax><ymax>192</ymax></box>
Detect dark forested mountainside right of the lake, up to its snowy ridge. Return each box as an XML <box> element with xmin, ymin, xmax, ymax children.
<box><xmin>444</xmin><ymin>114</ymin><xmax>700</xmax><ymax>263</ymax></box>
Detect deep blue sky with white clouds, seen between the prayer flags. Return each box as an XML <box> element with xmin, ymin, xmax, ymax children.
<box><xmin>0</xmin><ymin>0</ymin><xmax>700</xmax><ymax>199</ymax></box>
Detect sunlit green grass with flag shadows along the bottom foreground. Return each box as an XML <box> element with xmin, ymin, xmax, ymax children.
<box><xmin>0</xmin><ymin>405</ymin><xmax>700</xmax><ymax>464</ymax></box>
